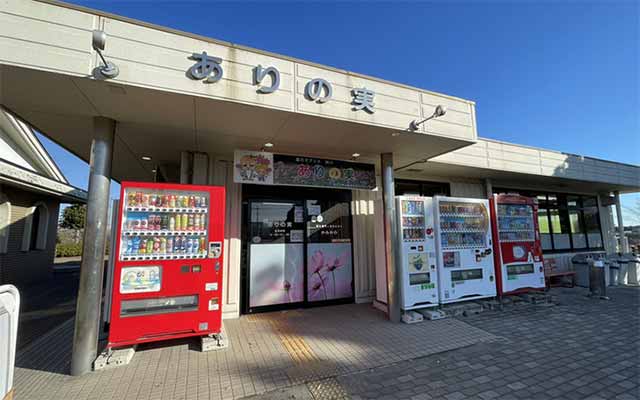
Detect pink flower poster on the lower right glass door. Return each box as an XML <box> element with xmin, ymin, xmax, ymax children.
<box><xmin>307</xmin><ymin>243</ymin><xmax>353</xmax><ymax>301</ymax></box>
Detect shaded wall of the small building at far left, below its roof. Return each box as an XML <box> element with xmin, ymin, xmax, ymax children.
<box><xmin>0</xmin><ymin>185</ymin><xmax>59</xmax><ymax>289</ymax></box>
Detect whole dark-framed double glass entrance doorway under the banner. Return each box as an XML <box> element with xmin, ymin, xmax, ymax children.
<box><xmin>241</xmin><ymin>185</ymin><xmax>354</xmax><ymax>313</ymax></box>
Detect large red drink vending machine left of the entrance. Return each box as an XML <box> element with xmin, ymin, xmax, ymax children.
<box><xmin>108</xmin><ymin>182</ymin><xmax>225</xmax><ymax>348</ymax></box>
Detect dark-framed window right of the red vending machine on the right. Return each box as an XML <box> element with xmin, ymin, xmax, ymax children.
<box><xmin>494</xmin><ymin>188</ymin><xmax>603</xmax><ymax>252</ymax></box>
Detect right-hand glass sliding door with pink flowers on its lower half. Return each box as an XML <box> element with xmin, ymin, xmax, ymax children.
<box><xmin>305</xmin><ymin>200</ymin><xmax>353</xmax><ymax>303</ymax></box>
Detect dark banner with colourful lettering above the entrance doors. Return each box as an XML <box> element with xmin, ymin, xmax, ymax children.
<box><xmin>233</xmin><ymin>150</ymin><xmax>376</xmax><ymax>190</ymax></box>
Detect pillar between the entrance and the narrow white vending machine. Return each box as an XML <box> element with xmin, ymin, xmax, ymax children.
<box><xmin>380</xmin><ymin>153</ymin><xmax>402</xmax><ymax>322</ymax></box>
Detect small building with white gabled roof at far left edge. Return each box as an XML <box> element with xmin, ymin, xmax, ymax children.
<box><xmin>0</xmin><ymin>108</ymin><xmax>86</xmax><ymax>289</ymax></box>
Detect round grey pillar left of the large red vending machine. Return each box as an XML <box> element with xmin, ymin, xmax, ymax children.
<box><xmin>71</xmin><ymin>117</ymin><xmax>116</xmax><ymax>375</ymax></box>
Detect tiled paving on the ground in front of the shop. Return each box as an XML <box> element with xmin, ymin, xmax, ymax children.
<box><xmin>15</xmin><ymin>287</ymin><xmax>640</xmax><ymax>400</ymax></box>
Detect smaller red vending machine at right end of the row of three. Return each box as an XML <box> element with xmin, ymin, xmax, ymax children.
<box><xmin>490</xmin><ymin>194</ymin><xmax>545</xmax><ymax>296</ymax></box>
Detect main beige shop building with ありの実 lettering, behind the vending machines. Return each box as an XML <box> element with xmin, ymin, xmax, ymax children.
<box><xmin>0</xmin><ymin>0</ymin><xmax>640</xmax><ymax>318</ymax></box>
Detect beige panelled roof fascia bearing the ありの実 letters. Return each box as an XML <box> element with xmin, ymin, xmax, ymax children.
<box><xmin>0</xmin><ymin>0</ymin><xmax>477</xmax><ymax>140</ymax></box>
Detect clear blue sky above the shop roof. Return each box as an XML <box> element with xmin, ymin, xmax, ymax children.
<box><xmin>40</xmin><ymin>0</ymin><xmax>640</xmax><ymax>223</ymax></box>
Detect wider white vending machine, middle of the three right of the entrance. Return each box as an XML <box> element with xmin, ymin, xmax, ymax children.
<box><xmin>433</xmin><ymin>196</ymin><xmax>496</xmax><ymax>304</ymax></box>
